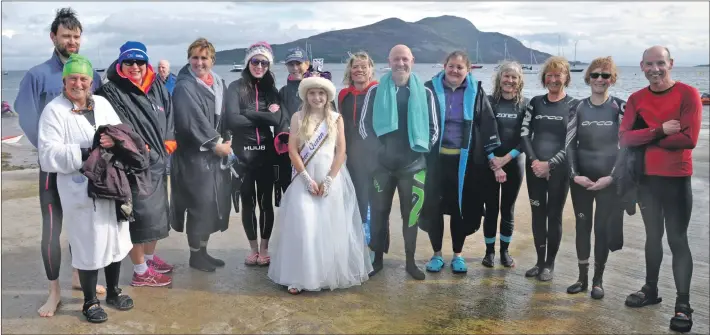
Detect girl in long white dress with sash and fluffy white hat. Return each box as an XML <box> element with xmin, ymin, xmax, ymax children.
<box><xmin>269</xmin><ymin>77</ymin><xmax>372</xmax><ymax>294</ymax></box>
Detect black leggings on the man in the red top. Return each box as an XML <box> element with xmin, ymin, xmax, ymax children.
<box><xmin>638</xmin><ymin>176</ymin><xmax>693</xmax><ymax>295</ymax></box>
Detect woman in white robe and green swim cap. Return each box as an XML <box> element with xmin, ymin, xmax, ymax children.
<box><xmin>38</xmin><ymin>54</ymin><xmax>133</xmax><ymax>323</ymax></box>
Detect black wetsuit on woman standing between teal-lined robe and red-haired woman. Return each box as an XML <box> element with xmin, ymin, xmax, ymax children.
<box><xmin>483</xmin><ymin>95</ymin><xmax>530</xmax><ymax>253</ymax></box>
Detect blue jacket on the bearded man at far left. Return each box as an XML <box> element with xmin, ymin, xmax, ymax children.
<box><xmin>14</xmin><ymin>51</ymin><xmax>101</xmax><ymax>148</ymax></box>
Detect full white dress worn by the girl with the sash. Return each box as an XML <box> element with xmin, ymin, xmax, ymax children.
<box><xmin>268</xmin><ymin>117</ymin><xmax>372</xmax><ymax>291</ymax></box>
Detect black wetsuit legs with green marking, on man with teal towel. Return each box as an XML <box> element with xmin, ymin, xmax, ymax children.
<box><xmin>370</xmin><ymin>170</ymin><xmax>426</xmax><ymax>257</ymax></box>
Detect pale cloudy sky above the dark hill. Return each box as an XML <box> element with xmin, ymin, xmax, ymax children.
<box><xmin>1</xmin><ymin>1</ymin><xmax>710</xmax><ymax>70</ymax></box>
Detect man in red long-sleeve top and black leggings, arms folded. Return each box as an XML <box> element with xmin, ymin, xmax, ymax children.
<box><xmin>619</xmin><ymin>46</ymin><xmax>702</xmax><ymax>332</ymax></box>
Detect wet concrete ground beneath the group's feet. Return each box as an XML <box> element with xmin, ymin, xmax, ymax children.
<box><xmin>1</xmin><ymin>143</ymin><xmax>710</xmax><ymax>334</ymax></box>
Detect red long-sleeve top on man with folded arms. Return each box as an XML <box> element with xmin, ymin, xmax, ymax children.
<box><xmin>619</xmin><ymin>82</ymin><xmax>703</xmax><ymax>177</ymax></box>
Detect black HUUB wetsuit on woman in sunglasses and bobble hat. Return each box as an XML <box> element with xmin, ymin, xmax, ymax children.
<box><xmin>226</xmin><ymin>78</ymin><xmax>283</xmax><ymax>241</ymax></box>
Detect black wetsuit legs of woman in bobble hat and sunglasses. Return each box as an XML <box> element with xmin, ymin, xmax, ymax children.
<box><xmin>240</xmin><ymin>165</ymin><xmax>274</xmax><ymax>241</ymax></box>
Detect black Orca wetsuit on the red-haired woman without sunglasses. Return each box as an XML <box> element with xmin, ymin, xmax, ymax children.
<box><xmin>521</xmin><ymin>95</ymin><xmax>576</xmax><ymax>280</ymax></box>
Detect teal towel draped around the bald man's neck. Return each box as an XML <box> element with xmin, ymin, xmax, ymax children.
<box><xmin>372</xmin><ymin>71</ymin><xmax>430</xmax><ymax>152</ymax></box>
